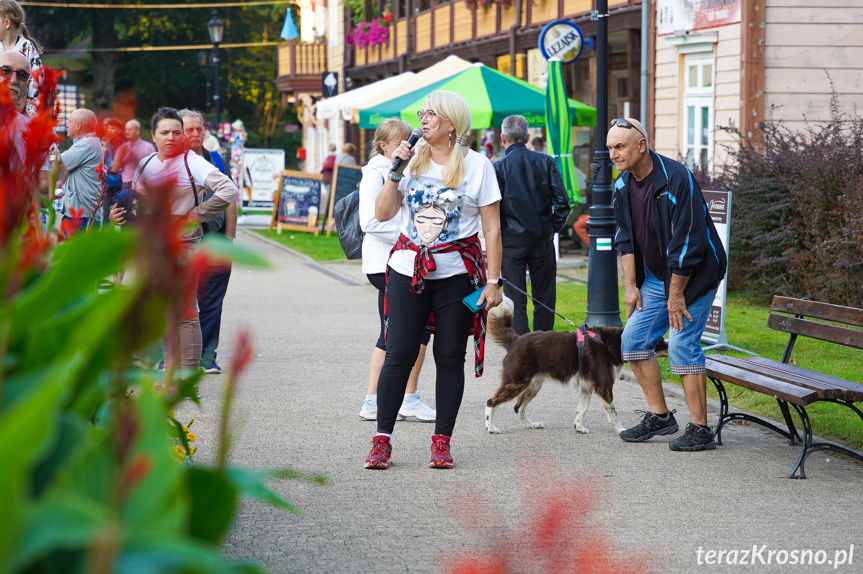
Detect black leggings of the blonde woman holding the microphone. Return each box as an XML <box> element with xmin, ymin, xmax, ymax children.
<box><xmin>378</xmin><ymin>269</ymin><xmax>474</xmax><ymax>436</ymax></box>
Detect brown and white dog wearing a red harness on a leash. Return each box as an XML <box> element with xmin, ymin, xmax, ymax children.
<box><xmin>485</xmin><ymin>297</ymin><xmax>668</xmax><ymax>434</ymax></box>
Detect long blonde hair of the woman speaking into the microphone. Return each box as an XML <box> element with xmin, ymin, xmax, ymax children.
<box><xmin>409</xmin><ymin>90</ymin><xmax>470</xmax><ymax>189</ymax></box>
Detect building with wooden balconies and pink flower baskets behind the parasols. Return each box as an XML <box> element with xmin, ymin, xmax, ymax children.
<box><xmin>276</xmin><ymin>0</ymin><xmax>641</xmax><ymax>176</ymax></box>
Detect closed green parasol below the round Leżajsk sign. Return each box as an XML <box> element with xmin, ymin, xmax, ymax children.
<box><xmin>545</xmin><ymin>58</ymin><xmax>580</xmax><ymax>205</ymax></box>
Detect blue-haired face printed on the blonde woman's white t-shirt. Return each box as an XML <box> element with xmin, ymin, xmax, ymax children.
<box><xmin>406</xmin><ymin>177</ymin><xmax>465</xmax><ymax>247</ymax></box>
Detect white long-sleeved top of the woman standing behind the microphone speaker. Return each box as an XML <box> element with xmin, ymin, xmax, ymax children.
<box><xmin>360</xmin><ymin>154</ymin><xmax>400</xmax><ymax>274</ymax></box>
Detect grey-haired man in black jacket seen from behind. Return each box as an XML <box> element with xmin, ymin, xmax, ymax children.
<box><xmin>494</xmin><ymin>116</ymin><xmax>569</xmax><ymax>335</ymax></box>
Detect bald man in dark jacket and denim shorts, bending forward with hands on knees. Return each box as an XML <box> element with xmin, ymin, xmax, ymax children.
<box><xmin>607</xmin><ymin>118</ymin><xmax>727</xmax><ymax>451</ymax></box>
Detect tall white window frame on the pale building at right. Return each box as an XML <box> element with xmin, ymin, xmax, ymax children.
<box><xmin>680</xmin><ymin>53</ymin><xmax>716</xmax><ymax>171</ymax></box>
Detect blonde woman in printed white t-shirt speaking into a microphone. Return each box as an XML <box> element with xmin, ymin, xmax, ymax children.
<box><xmin>365</xmin><ymin>91</ymin><xmax>503</xmax><ymax>469</ymax></box>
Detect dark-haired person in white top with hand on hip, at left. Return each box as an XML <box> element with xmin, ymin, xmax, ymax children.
<box><xmin>110</xmin><ymin>108</ymin><xmax>239</xmax><ymax>378</ymax></box>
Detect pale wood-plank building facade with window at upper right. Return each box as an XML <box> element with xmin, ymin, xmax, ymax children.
<box><xmin>648</xmin><ymin>0</ymin><xmax>863</xmax><ymax>168</ymax></box>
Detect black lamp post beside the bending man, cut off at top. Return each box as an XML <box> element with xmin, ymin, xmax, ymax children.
<box><xmin>586</xmin><ymin>0</ymin><xmax>622</xmax><ymax>327</ymax></box>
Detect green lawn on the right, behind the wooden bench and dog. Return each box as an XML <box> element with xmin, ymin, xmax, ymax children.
<box><xmin>548</xmin><ymin>282</ymin><xmax>863</xmax><ymax>449</ymax></box>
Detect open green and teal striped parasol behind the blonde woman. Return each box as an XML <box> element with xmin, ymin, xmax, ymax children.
<box><xmin>359</xmin><ymin>64</ymin><xmax>596</xmax><ymax>129</ymax></box>
